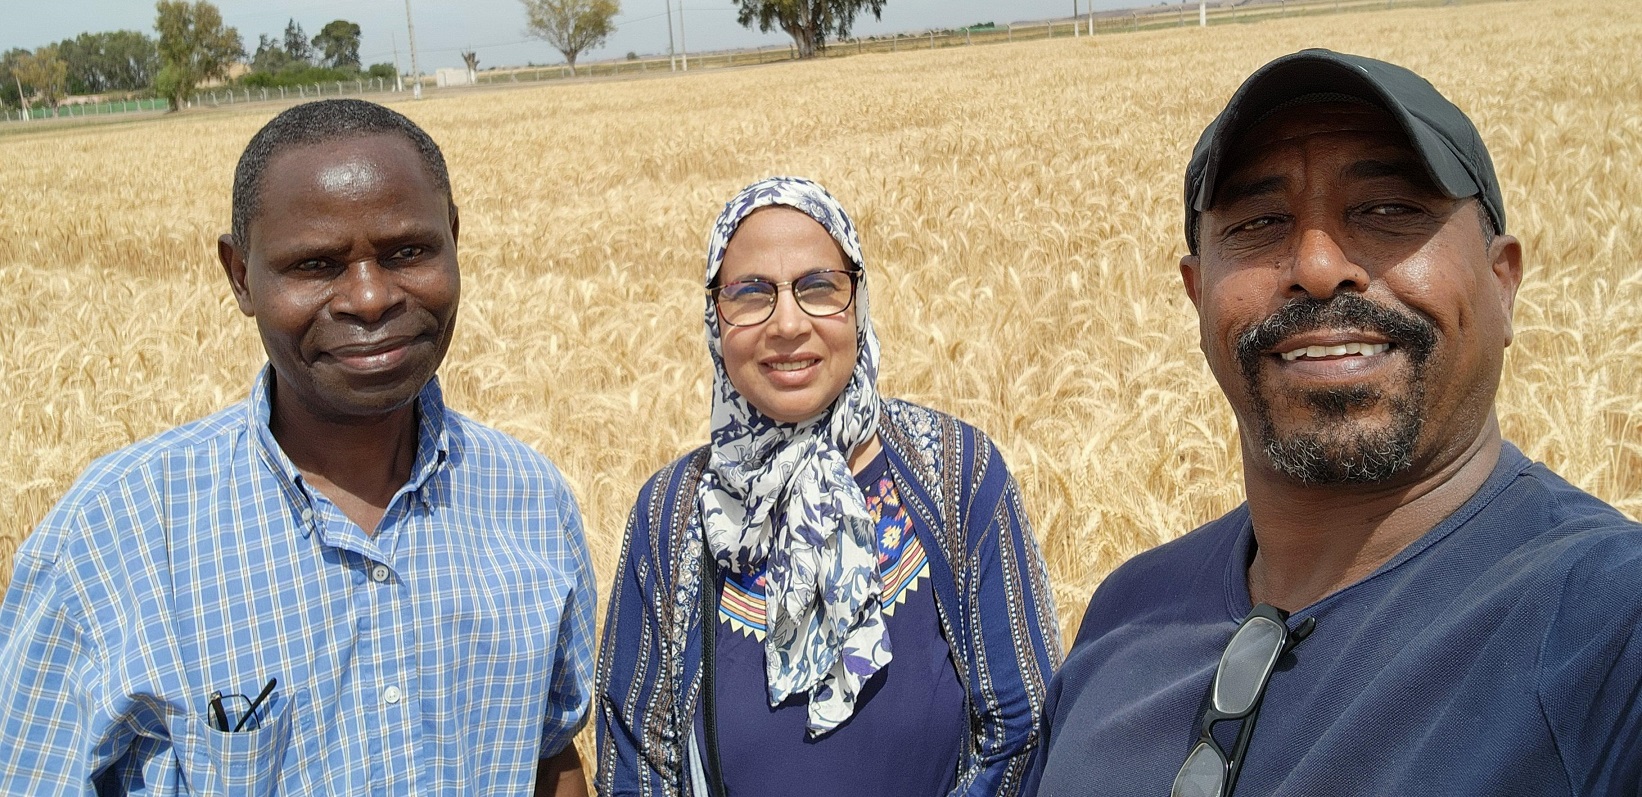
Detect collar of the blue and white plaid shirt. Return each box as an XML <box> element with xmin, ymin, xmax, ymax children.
<box><xmin>246</xmin><ymin>363</ymin><xmax>450</xmax><ymax>536</ymax></box>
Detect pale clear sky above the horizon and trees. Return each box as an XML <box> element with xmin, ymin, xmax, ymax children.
<box><xmin>0</xmin><ymin>0</ymin><xmax>1148</xmax><ymax>72</ymax></box>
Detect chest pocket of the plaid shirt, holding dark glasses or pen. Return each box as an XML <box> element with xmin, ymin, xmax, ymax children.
<box><xmin>171</xmin><ymin>695</ymin><xmax>296</xmax><ymax>797</ymax></box>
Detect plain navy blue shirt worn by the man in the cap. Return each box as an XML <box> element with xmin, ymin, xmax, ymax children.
<box><xmin>1028</xmin><ymin>444</ymin><xmax>1642</xmax><ymax>797</ymax></box>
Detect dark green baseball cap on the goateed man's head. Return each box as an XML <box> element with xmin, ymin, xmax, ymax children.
<box><xmin>1186</xmin><ymin>49</ymin><xmax>1506</xmax><ymax>255</ymax></box>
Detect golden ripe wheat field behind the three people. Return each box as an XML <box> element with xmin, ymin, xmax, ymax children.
<box><xmin>0</xmin><ymin>0</ymin><xmax>1642</xmax><ymax>647</ymax></box>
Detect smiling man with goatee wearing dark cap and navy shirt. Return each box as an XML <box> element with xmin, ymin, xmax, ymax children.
<box><xmin>1036</xmin><ymin>49</ymin><xmax>1642</xmax><ymax>797</ymax></box>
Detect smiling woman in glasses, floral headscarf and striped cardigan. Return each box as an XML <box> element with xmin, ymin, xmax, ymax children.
<box><xmin>596</xmin><ymin>177</ymin><xmax>1061</xmax><ymax>797</ymax></box>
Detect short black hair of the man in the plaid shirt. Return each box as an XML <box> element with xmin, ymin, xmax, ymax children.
<box><xmin>232</xmin><ymin>100</ymin><xmax>455</xmax><ymax>251</ymax></box>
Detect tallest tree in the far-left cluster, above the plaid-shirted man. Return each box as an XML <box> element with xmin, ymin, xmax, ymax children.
<box><xmin>154</xmin><ymin>0</ymin><xmax>245</xmax><ymax>110</ymax></box>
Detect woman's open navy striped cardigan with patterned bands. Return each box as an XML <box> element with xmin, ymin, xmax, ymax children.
<box><xmin>594</xmin><ymin>399</ymin><xmax>1062</xmax><ymax>797</ymax></box>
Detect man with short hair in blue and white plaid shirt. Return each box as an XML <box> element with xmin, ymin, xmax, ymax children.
<box><xmin>0</xmin><ymin>100</ymin><xmax>596</xmax><ymax>795</ymax></box>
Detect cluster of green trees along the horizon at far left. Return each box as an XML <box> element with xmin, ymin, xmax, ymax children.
<box><xmin>0</xmin><ymin>0</ymin><xmax>396</xmax><ymax>113</ymax></box>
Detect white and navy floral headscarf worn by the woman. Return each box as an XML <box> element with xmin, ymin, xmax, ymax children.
<box><xmin>696</xmin><ymin>177</ymin><xmax>890</xmax><ymax>736</ymax></box>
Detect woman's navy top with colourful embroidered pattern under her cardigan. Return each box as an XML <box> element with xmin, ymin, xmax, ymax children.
<box><xmin>696</xmin><ymin>454</ymin><xmax>969</xmax><ymax>797</ymax></box>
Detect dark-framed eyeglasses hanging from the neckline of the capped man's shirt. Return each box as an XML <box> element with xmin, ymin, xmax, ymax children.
<box><xmin>1169</xmin><ymin>603</ymin><xmax>1317</xmax><ymax>797</ymax></box>
